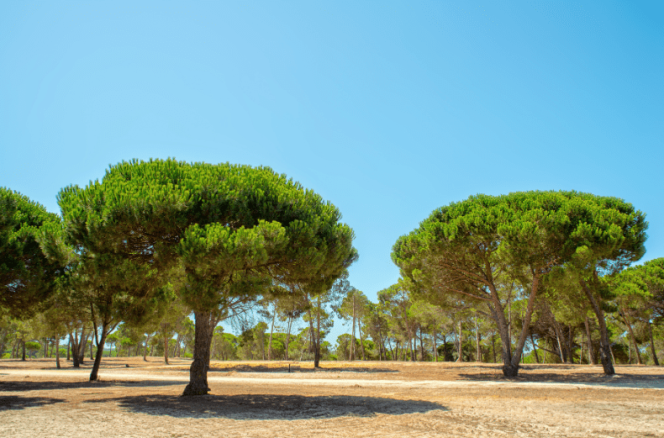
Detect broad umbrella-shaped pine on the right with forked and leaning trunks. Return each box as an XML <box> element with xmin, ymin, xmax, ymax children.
<box><xmin>392</xmin><ymin>192</ymin><xmax>647</xmax><ymax>377</ymax></box>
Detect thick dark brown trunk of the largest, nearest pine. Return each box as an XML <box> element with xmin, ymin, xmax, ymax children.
<box><xmin>183</xmin><ymin>312</ymin><xmax>213</xmax><ymax>396</ymax></box>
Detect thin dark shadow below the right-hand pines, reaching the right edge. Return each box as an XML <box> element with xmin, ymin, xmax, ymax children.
<box><xmin>459</xmin><ymin>372</ymin><xmax>664</xmax><ymax>388</ymax></box>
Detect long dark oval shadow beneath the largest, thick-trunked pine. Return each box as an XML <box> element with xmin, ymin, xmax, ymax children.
<box><xmin>86</xmin><ymin>394</ymin><xmax>447</xmax><ymax>420</ymax></box>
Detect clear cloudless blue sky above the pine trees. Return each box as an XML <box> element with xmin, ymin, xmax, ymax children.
<box><xmin>0</xmin><ymin>0</ymin><xmax>664</xmax><ymax>341</ymax></box>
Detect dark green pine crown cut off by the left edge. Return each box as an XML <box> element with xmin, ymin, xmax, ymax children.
<box><xmin>0</xmin><ymin>187</ymin><xmax>62</xmax><ymax>318</ymax></box>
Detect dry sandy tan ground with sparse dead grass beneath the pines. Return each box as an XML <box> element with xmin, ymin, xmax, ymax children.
<box><xmin>0</xmin><ymin>358</ymin><xmax>664</xmax><ymax>438</ymax></box>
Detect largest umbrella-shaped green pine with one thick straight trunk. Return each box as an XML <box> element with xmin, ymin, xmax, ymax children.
<box><xmin>61</xmin><ymin>160</ymin><xmax>356</xmax><ymax>395</ymax></box>
